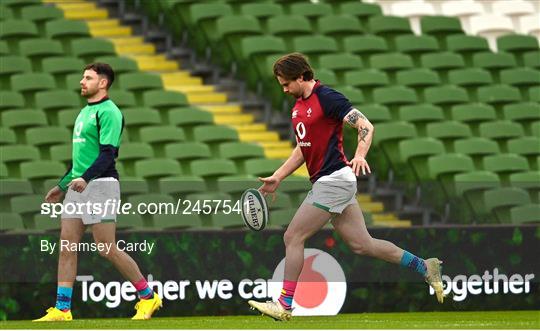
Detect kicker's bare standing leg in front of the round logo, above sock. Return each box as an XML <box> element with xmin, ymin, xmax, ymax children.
<box><xmin>283</xmin><ymin>203</ymin><xmax>330</xmax><ymax>281</ymax></box>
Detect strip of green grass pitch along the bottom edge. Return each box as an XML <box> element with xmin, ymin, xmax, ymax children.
<box><xmin>0</xmin><ymin>311</ymin><xmax>540</xmax><ymax>329</ymax></box>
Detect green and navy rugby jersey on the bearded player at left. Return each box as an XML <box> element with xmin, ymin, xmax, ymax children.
<box><xmin>58</xmin><ymin>98</ymin><xmax>124</xmax><ymax>191</ymax></box>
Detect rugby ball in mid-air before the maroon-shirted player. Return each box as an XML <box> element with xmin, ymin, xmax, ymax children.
<box><xmin>240</xmin><ymin>188</ymin><xmax>268</xmax><ymax>231</ymax></box>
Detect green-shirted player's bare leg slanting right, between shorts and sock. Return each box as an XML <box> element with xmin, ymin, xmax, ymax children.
<box><xmin>92</xmin><ymin>223</ymin><xmax>143</xmax><ymax>283</ymax></box>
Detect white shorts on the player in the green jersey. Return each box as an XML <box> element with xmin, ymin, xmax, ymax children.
<box><xmin>62</xmin><ymin>177</ymin><xmax>120</xmax><ymax>224</ymax></box>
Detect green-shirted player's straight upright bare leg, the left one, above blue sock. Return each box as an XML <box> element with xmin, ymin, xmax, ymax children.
<box><xmin>58</xmin><ymin>218</ymin><xmax>86</xmax><ymax>288</ymax></box>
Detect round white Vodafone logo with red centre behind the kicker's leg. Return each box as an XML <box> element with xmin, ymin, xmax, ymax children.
<box><xmin>268</xmin><ymin>248</ymin><xmax>347</xmax><ymax>316</ymax></box>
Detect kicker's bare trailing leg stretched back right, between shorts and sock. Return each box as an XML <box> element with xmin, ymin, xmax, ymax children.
<box><xmin>332</xmin><ymin>204</ymin><xmax>403</xmax><ymax>264</ymax></box>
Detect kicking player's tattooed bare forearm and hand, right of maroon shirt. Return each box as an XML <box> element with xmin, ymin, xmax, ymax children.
<box><xmin>343</xmin><ymin>108</ymin><xmax>374</xmax><ymax>176</ymax></box>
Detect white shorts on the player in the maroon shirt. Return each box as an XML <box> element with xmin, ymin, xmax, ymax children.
<box><xmin>304</xmin><ymin>167</ymin><xmax>358</xmax><ymax>214</ymax></box>
